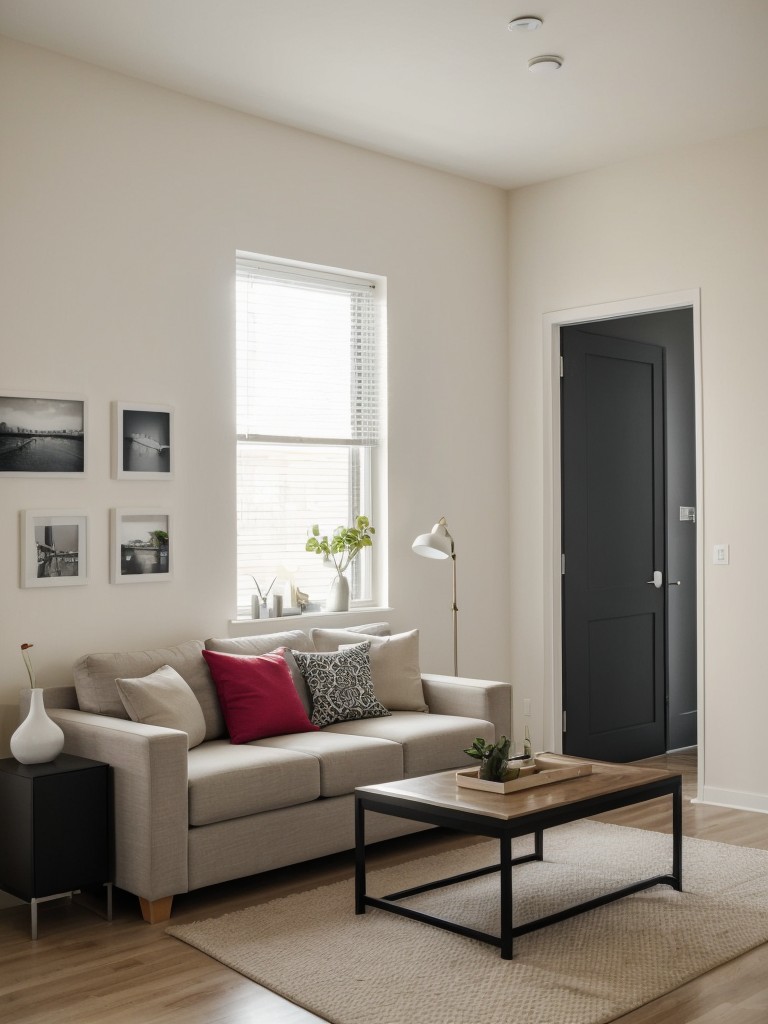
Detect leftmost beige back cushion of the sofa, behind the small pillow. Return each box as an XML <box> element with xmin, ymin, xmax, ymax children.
<box><xmin>74</xmin><ymin>640</ymin><xmax>225</xmax><ymax>739</ymax></box>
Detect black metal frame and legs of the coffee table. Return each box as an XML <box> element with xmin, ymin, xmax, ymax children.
<box><xmin>354</xmin><ymin>775</ymin><xmax>683</xmax><ymax>959</ymax></box>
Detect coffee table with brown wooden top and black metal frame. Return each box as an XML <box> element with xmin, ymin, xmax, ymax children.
<box><xmin>354</xmin><ymin>755</ymin><xmax>683</xmax><ymax>959</ymax></box>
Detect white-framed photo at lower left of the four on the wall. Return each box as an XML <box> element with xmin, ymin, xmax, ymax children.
<box><xmin>19</xmin><ymin>510</ymin><xmax>88</xmax><ymax>587</ymax></box>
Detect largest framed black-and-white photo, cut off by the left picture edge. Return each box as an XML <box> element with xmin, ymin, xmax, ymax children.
<box><xmin>0</xmin><ymin>391</ymin><xmax>86</xmax><ymax>477</ymax></box>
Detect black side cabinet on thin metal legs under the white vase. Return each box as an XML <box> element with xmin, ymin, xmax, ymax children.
<box><xmin>0</xmin><ymin>754</ymin><xmax>112</xmax><ymax>939</ymax></box>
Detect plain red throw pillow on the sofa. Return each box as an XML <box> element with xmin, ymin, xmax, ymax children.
<box><xmin>203</xmin><ymin>647</ymin><xmax>317</xmax><ymax>743</ymax></box>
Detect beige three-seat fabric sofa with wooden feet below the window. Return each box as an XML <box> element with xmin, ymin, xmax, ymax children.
<box><xmin>30</xmin><ymin>624</ymin><xmax>511</xmax><ymax>923</ymax></box>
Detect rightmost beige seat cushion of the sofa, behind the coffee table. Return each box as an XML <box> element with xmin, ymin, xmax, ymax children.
<box><xmin>328</xmin><ymin>711</ymin><xmax>495</xmax><ymax>778</ymax></box>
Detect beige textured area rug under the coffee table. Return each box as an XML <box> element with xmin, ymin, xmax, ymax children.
<box><xmin>168</xmin><ymin>821</ymin><xmax>768</xmax><ymax>1024</ymax></box>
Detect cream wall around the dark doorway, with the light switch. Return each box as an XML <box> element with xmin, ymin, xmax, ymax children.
<box><xmin>510</xmin><ymin>130</ymin><xmax>768</xmax><ymax>811</ymax></box>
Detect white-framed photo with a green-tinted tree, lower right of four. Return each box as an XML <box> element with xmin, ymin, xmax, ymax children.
<box><xmin>111</xmin><ymin>509</ymin><xmax>173</xmax><ymax>583</ymax></box>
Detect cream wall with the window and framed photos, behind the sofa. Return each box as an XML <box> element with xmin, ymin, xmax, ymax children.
<box><xmin>0</xmin><ymin>40</ymin><xmax>518</xmax><ymax>756</ymax></box>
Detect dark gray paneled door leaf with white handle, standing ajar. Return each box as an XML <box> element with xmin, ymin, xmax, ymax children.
<box><xmin>561</xmin><ymin>328</ymin><xmax>667</xmax><ymax>761</ymax></box>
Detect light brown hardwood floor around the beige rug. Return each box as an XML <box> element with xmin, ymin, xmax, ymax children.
<box><xmin>0</xmin><ymin>753</ymin><xmax>768</xmax><ymax>1024</ymax></box>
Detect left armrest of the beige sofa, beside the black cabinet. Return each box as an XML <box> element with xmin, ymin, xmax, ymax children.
<box><xmin>48</xmin><ymin>709</ymin><xmax>188</xmax><ymax>901</ymax></box>
